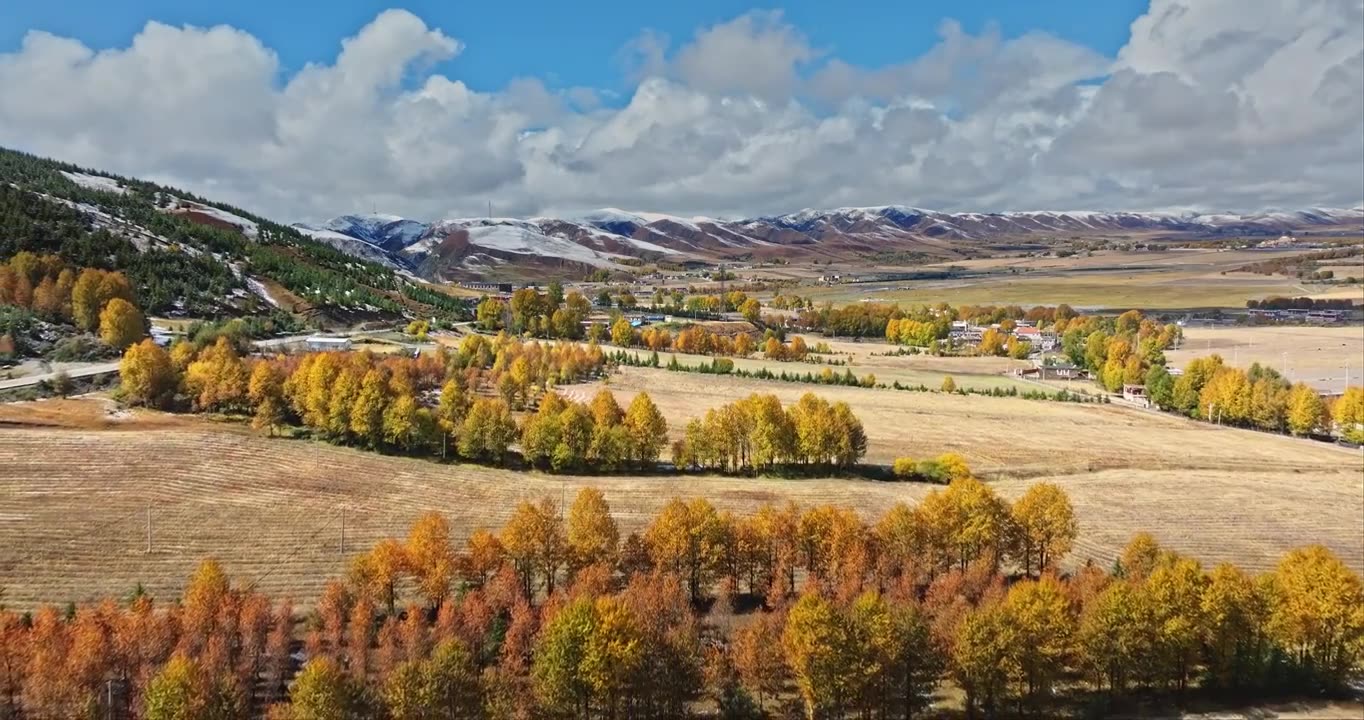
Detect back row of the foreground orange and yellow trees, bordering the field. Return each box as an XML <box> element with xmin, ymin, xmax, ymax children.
<box><xmin>349</xmin><ymin>470</ymin><xmax>1076</xmax><ymax>612</ymax></box>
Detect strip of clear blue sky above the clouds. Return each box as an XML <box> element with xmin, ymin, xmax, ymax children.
<box><xmin>0</xmin><ymin>0</ymin><xmax>1147</xmax><ymax>91</ymax></box>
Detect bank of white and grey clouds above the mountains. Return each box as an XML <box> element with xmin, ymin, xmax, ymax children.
<box><xmin>0</xmin><ymin>0</ymin><xmax>1364</xmax><ymax>221</ymax></box>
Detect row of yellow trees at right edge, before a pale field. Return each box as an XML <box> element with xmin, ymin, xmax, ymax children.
<box><xmin>1146</xmin><ymin>355</ymin><xmax>1364</xmax><ymax>442</ymax></box>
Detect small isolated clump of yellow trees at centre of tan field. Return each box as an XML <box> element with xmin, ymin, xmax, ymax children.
<box><xmin>672</xmin><ymin>393</ymin><xmax>866</xmax><ymax>472</ymax></box>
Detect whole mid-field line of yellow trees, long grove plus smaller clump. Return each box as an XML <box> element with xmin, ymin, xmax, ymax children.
<box><xmin>120</xmin><ymin>334</ymin><xmax>866</xmax><ymax>472</ymax></box>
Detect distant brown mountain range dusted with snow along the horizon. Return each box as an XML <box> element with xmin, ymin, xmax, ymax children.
<box><xmin>295</xmin><ymin>205</ymin><xmax>1364</xmax><ymax>280</ymax></box>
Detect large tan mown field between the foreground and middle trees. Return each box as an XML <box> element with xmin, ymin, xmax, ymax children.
<box><xmin>0</xmin><ymin>379</ymin><xmax>1364</xmax><ymax>608</ymax></box>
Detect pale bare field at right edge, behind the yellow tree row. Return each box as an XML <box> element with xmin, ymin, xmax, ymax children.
<box><xmin>1165</xmin><ymin>325</ymin><xmax>1364</xmax><ymax>393</ymax></box>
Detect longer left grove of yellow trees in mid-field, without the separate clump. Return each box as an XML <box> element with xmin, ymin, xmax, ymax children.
<box><xmin>120</xmin><ymin>335</ymin><xmax>604</xmax><ymax>462</ymax></box>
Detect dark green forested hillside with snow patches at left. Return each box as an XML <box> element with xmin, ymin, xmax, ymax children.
<box><xmin>0</xmin><ymin>149</ymin><xmax>466</xmax><ymax>322</ymax></box>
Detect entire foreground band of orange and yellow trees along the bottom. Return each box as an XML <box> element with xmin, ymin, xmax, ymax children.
<box><xmin>0</xmin><ymin>477</ymin><xmax>1364</xmax><ymax>720</ymax></box>
